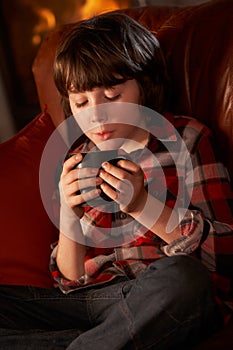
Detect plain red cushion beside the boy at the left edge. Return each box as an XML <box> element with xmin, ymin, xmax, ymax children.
<box><xmin>0</xmin><ymin>114</ymin><xmax>58</xmax><ymax>287</ymax></box>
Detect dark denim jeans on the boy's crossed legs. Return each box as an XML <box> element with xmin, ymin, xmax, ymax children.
<box><xmin>0</xmin><ymin>255</ymin><xmax>220</xmax><ymax>350</ymax></box>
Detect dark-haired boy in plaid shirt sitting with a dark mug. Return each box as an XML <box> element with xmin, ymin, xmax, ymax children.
<box><xmin>1</xmin><ymin>13</ymin><xmax>233</xmax><ymax>350</ymax></box>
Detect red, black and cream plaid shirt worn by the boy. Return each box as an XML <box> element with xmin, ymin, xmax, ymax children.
<box><xmin>50</xmin><ymin>114</ymin><xmax>233</xmax><ymax>326</ymax></box>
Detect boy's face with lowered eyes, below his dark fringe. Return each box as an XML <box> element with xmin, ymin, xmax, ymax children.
<box><xmin>69</xmin><ymin>79</ymin><xmax>148</xmax><ymax>149</ymax></box>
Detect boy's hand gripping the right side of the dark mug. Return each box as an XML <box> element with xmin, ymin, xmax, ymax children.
<box><xmin>99</xmin><ymin>160</ymin><xmax>147</xmax><ymax>214</ymax></box>
